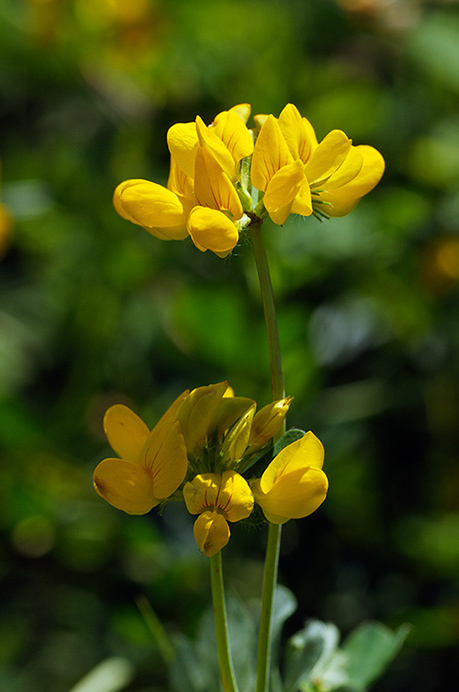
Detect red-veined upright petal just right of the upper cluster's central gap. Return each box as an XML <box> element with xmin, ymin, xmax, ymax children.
<box><xmin>251</xmin><ymin>115</ymin><xmax>293</xmax><ymax>192</ymax></box>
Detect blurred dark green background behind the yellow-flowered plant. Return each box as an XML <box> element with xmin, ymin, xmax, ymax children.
<box><xmin>0</xmin><ymin>0</ymin><xmax>459</xmax><ymax>692</ymax></box>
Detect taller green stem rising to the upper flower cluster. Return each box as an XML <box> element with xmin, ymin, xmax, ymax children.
<box><xmin>250</xmin><ymin>220</ymin><xmax>285</xmax><ymax>692</ymax></box>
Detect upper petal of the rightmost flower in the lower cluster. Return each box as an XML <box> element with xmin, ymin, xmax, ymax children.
<box><xmin>260</xmin><ymin>431</ymin><xmax>324</xmax><ymax>493</ymax></box>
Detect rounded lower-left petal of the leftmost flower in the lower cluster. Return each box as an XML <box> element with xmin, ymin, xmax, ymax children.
<box><xmin>93</xmin><ymin>459</ymin><xmax>159</xmax><ymax>514</ymax></box>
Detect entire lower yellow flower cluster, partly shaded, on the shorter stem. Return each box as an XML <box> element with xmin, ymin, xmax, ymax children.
<box><xmin>94</xmin><ymin>382</ymin><xmax>328</xmax><ymax>557</ymax></box>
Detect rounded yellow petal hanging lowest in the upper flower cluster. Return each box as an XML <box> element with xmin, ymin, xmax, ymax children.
<box><xmin>187</xmin><ymin>207</ymin><xmax>239</xmax><ymax>257</ymax></box>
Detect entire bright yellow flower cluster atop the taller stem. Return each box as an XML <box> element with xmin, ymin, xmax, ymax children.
<box><xmin>113</xmin><ymin>104</ymin><xmax>384</xmax><ymax>257</ymax></box>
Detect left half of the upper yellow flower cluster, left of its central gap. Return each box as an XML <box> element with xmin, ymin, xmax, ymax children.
<box><xmin>113</xmin><ymin>104</ymin><xmax>253</xmax><ymax>257</ymax></box>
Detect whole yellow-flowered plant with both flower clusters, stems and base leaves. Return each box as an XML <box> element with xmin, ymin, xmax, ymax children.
<box><xmin>94</xmin><ymin>104</ymin><xmax>406</xmax><ymax>692</ymax></box>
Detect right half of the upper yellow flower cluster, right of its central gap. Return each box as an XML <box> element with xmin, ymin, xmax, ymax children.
<box><xmin>251</xmin><ymin>103</ymin><xmax>384</xmax><ymax>225</ymax></box>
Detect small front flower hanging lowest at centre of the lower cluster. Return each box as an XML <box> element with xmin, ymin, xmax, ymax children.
<box><xmin>183</xmin><ymin>471</ymin><xmax>254</xmax><ymax>557</ymax></box>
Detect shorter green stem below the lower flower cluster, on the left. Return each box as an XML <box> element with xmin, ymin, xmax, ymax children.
<box><xmin>209</xmin><ymin>552</ymin><xmax>238</xmax><ymax>692</ymax></box>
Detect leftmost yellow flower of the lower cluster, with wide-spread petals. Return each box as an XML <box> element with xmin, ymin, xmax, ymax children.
<box><xmin>93</xmin><ymin>392</ymin><xmax>188</xmax><ymax>514</ymax></box>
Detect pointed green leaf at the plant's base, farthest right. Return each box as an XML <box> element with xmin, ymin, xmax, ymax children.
<box><xmin>342</xmin><ymin>622</ymin><xmax>410</xmax><ymax>688</ymax></box>
